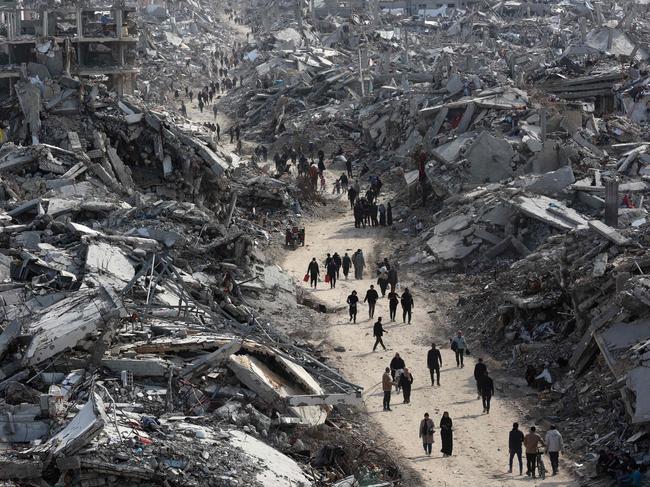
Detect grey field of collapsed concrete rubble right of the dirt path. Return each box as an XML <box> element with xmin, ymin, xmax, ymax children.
<box><xmin>225</xmin><ymin>1</ymin><xmax>650</xmax><ymax>485</ymax></box>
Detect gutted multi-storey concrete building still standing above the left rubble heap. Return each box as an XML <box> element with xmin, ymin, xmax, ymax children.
<box><xmin>0</xmin><ymin>0</ymin><xmax>138</xmax><ymax>97</ymax></box>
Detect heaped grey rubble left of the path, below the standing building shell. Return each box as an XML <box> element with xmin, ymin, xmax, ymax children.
<box><xmin>0</xmin><ymin>2</ymin><xmax>416</xmax><ymax>486</ymax></box>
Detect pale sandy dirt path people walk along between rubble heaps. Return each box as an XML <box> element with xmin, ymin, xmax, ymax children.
<box><xmin>284</xmin><ymin>173</ymin><xmax>574</xmax><ymax>487</ymax></box>
